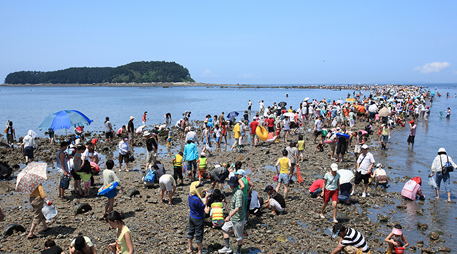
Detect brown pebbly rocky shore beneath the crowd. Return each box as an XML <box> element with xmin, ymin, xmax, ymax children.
<box><xmin>0</xmin><ymin>119</ymin><xmax>450</xmax><ymax>253</ymax></box>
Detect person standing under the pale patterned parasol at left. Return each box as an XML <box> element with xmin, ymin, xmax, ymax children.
<box><xmin>27</xmin><ymin>184</ymin><xmax>51</xmax><ymax>239</ymax></box>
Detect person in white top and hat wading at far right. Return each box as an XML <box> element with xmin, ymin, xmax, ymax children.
<box><xmin>431</xmin><ymin>148</ymin><xmax>457</xmax><ymax>202</ymax></box>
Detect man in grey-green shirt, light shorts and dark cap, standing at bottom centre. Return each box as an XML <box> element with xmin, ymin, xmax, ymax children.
<box><xmin>219</xmin><ymin>176</ymin><xmax>246</xmax><ymax>254</ymax></box>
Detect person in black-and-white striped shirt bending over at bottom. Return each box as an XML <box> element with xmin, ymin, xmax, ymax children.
<box><xmin>331</xmin><ymin>223</ymin><xmax>370</xmax><ymax>254</ymax></box>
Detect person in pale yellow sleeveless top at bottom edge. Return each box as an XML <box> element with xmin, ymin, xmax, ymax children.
<box><xmin>106</xmin><ymin>211</ymin><xmax>135</xmax><ymax>254</ymax></box>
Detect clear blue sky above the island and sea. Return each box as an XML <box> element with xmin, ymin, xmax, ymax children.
<box><xmin>0</xmin><ymin>0</ymin><xmax>457</xmax><ymax>84</ymax></box>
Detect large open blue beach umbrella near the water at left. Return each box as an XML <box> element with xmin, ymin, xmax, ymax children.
<box><xmin>38</xmin><ymin>110</ymin><xmax>92</xmax><ymax>130</ymax></box>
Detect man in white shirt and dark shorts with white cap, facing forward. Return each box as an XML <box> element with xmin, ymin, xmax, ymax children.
<box><xmin>351</xmin><ymin>145</ymin><xmax>375</xmax><ymax>198</ymax></box>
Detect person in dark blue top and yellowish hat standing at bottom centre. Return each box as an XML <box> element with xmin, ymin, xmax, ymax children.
<box><xmin>186</xmin><ymin>181</ymin><xmax>210</xmax><ymax>254</ymax></box>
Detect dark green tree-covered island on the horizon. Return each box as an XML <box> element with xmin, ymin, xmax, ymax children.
<box><xmin>5</xmin><ymin>61</ymin><xmax>195</xmax><ymax>84</ymax></box>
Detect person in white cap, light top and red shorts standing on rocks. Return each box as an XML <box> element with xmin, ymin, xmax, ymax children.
<box><xmin>321</xmin><ymin>163</ymin><xmax>340</xmax><ymax>223</ymax></box>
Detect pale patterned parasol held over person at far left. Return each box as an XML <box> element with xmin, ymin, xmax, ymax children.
<box><xmin>16</xmin><ymin>162</ymin><xmax>47</xmax><ymax>193</ymax></box>
